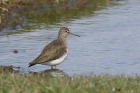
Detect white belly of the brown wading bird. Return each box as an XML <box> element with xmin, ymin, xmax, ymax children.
<box><xmin>41</xmin><ymin>52</ymin><xmax>68</xmax><ymax>66</ymax></box>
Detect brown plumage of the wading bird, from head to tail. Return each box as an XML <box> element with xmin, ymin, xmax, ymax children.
<box><xmin>29</xmin><ymin>27</ymin><xmax>78</xmax><ymax>67</ymax></box>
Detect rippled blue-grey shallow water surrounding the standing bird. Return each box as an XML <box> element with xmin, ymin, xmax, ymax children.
<box><xmin>0</xmin><ymin>0</ymin><xmax>140</xmax><ymax>75</ymax></box>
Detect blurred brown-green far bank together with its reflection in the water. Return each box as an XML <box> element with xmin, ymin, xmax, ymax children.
<box><xmin>0</xmin><ymin>0</ymin><xmax>113</xmax><ymax>31</ymax></box>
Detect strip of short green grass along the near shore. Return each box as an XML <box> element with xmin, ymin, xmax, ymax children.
<box><xmin>0</xmin><ymin>74</ymin><xmax>140</xmax><ymax>93</ymax></box>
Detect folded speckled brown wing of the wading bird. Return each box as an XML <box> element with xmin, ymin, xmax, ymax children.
<box><xmin>29</xmin><ymin>40</ymin><xmax>67</xmax><ymax>67</ymax></box>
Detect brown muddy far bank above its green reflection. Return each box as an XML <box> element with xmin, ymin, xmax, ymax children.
<box><xmin>0</xmin><ymin>0</ymin><xmax>88</xmax><ymax>31</ymax></box>
